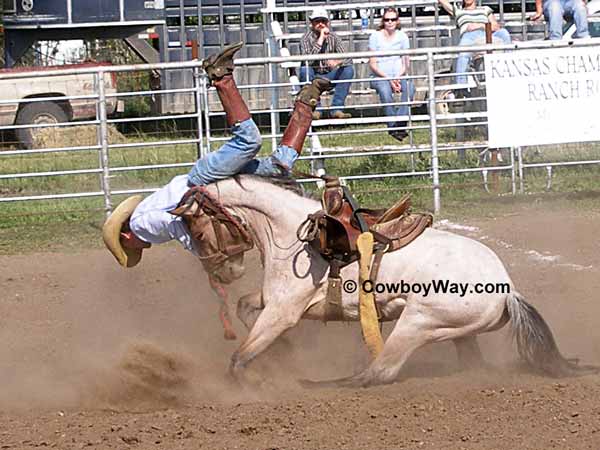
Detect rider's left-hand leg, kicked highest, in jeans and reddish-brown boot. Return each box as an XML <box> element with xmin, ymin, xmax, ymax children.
<box><xmin>188</xmin><ymin>43</ymin><xmax>261</xmax><ymax>185</ymax></box>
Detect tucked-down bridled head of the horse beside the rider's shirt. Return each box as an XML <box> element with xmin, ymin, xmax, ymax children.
<box><xmin>171</xmin><ymin>191</ymin><xmax>252</xmax><ymax>284</ymax></box>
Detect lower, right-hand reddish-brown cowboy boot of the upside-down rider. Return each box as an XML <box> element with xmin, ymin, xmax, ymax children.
<box><xmin>281</xmin><ymin>77</ymin><xmax>331</xmax><ymax>154</ymax></box>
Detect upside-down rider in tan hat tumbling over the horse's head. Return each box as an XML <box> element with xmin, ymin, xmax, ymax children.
<box><xmin>102</xmin><ymin>42</ymin><xmax>331</xmax><ymax>267</ymax></box>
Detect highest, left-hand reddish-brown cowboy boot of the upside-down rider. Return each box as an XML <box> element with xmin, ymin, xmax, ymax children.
<box><xmin>202</xmin><ymin>42</ymin><xmax>251</xmax><ymax>127</ymax></box>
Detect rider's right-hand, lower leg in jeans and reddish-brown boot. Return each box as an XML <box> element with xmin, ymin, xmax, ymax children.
<box><xmin>241</xmin><ymin>78</ymin><xmax>331</xmax><ymax>176</ymax></box>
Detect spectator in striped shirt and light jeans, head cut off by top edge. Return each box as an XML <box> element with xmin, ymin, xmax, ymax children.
<box><xmin>438</xmin><ymin>0</ymin><xmax>512</xmax><ymax>84</ymax></box>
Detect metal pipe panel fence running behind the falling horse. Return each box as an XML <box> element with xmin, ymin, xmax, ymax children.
<box><xmin>0</xmin><ymin>40</ymin><xmax>600</xmax><ymax>218</ymax></box>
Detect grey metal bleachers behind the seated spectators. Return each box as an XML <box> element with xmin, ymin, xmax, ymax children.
<box><xmin>196</xmin><ymin>0</ymin><xmax>544</xmax><ymax>118</ymax></box>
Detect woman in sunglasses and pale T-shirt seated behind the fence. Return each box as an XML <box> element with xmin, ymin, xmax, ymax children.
<box><xmin>369</xmin><ymin>8</ymin><xmax>415</xmax><ymax>141</ymax></box>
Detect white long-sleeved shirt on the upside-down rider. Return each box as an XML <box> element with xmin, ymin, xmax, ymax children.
<box><xmin>129</xmin><ymin>175</ymin><xmax>198</xmax><ymax>256</ymax></box>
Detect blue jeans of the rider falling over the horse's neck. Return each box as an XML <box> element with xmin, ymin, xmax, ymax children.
<box><xmin>188</xmin><ymin>119</ymin><xmax>298</xmax><ymax>186</ymax></box>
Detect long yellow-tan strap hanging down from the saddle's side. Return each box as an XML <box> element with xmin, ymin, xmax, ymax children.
<box><xmin>356</xmin><ymin>231</ymin><xmax>383</xmax><ymax>358</ymax></box>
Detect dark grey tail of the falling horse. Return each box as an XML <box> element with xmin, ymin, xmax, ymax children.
<box><xmin>506</xmin><ymin>292</ymin><xmax>600</xmax><ymax>377</ymax></box>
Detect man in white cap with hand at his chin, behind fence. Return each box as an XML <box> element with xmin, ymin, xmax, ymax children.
<box><xmin>300</xmin><ymin>7</ymin><xmax>354</xmax><ymax>119</ymax></box>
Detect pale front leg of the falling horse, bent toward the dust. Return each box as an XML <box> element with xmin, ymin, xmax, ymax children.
<box><xmin>229</xmin><ymin>292</ymin><xmax>314</xmax><ymax>379</ymax></box>
